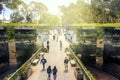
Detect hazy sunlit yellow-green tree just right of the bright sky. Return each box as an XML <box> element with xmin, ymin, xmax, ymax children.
<box><xmin>60</xmin><ymin>0</ymin><xmax>91</xmax><ymax>24</ymax></box>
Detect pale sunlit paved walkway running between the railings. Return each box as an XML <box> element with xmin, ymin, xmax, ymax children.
<box><xmin>28</xmin><ymin>31</ymin><xmax>76</xmax><ymax>80</ymax></box>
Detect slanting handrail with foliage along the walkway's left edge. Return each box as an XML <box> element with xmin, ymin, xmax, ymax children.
<box><xmin>7</xmin><ymin>48</ymin><xmax>41</xmax><ymax>80</ymax></box>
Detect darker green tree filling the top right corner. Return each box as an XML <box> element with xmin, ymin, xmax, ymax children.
<box><xmin>91</xmin><ymin>0</ymin><xmax>120</xmax><ymax>23</ymax></box>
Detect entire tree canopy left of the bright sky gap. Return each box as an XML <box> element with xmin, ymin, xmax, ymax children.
<box><xmin>0</xmin><ymin>0</ymin><xmax>60</xmax><ymax>25</ymax></box>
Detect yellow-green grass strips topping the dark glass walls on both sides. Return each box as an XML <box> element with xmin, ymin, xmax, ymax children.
<box><xmin>0</xmin><ymin>23</ymin><xmax>120</xmax><ymax>27</ymax></box>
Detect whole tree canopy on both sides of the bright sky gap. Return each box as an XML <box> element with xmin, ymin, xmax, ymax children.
<box><xmin>0</xmin><ymin>0</ymin><xmax>120</xmax><ymax>25</ymax></box>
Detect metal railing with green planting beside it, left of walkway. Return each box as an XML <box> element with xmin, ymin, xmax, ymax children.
<box><xmin>7</xmin><ymin>45</ymin><xmax>41</xmax><ymax>80</ymax></box>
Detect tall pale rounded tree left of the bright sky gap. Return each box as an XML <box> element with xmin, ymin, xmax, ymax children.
<box><xmin>28</xmin><ymin>1</ymin><xmax>48</xmax><ymax>23</ymax></box>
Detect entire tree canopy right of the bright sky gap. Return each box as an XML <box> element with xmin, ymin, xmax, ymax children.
<box><xmin>60</xmin><ymin>0</ymin><xmax>120</xmax><ymax>24</ymax></box>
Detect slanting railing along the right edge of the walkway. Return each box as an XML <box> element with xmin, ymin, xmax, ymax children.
<box><xmin>69</xmin><ymin>48</ymin><xmax>95</xmax><ymax>80</ymax></box>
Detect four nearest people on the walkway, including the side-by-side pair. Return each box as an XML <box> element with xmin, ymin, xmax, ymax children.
<box><xmin>40</xmin><ymin>57</ymin><xmax>69</xmax><ymax>80</ymax></box>
